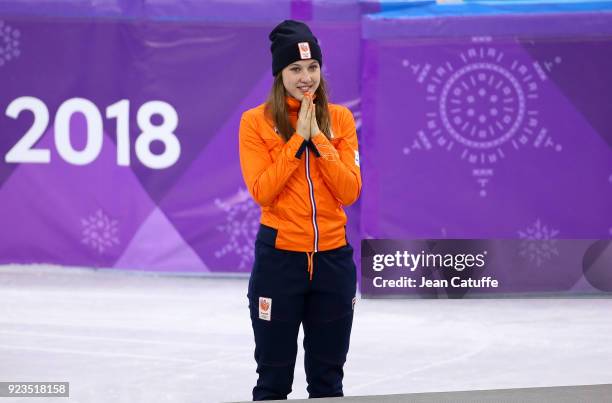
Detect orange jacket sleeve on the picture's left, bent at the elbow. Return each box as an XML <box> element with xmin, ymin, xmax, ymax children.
<box><xmin>239</xmin><ymin>113</ymin><xmax>304</xmax><ymax>207</ymax></box>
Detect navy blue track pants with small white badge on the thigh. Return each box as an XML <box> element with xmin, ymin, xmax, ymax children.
<box><xmin>248</xmin><ymin>240</ymin><xmax>356</xmax><ymax>400</ymax></box>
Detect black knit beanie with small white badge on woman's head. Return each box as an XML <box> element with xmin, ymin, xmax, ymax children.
<box><xmin>269</xmin><ymin>20</ymin><xmax>323</xmax><ymax>76</ymax></box>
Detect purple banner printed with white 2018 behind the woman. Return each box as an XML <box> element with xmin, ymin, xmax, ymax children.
<box><xmin>0</xmin><ymin>14</ymin><xmax>359</xmax><ymax>273</ymax></box>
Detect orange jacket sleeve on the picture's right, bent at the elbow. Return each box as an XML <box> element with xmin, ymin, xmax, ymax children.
<box><xmin>312</xmin><ymin>108</ymin><xmax>361</xmax><ymax>206</ymax></box>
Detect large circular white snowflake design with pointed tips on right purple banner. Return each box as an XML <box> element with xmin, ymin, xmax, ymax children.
<box><xmin>401</xmin><ymin>37</ymin><xmax>562</xmax><ymax>197</ymax></box>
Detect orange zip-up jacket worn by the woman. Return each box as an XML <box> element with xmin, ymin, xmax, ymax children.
<box><xmin>240</xmin><ymin>97</ymin><xmax>361</xmax><ymax>252</ymax></box>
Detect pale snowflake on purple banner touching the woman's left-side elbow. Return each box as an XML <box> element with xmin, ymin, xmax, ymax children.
<box><xmin>215</xmin><ymin>189</ymin><xmax>260</xmax><ymax>270</ymax></box>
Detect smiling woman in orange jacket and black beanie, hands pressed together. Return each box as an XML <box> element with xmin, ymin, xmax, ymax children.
<box><xmin>240</xmin><ymin>20</ymin><xmax>361</xmax><ymax>400</ymax></box>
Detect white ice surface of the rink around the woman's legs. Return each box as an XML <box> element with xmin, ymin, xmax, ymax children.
<box><xmin>0</xmin><ymin>266</ymin><xmax>612</xmax><ymax>403</ymax></box>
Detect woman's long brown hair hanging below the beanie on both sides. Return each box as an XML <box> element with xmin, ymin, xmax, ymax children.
<box><xmin>265</xmin><ymin>72</ymin><xmax>332</xmax><ymax>142</ymax></box>
